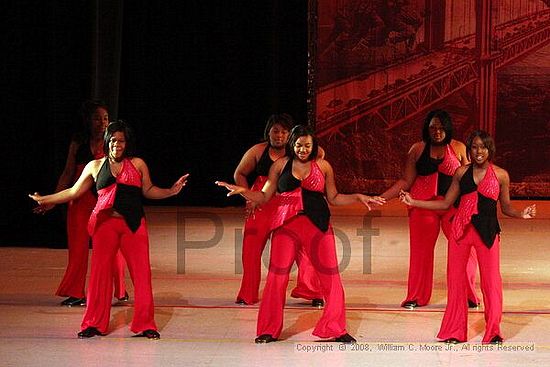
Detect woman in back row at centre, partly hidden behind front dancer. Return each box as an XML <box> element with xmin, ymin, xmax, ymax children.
<box><xmin>233</xmin><ymin>113</ymin><xmax>324</xmax><ymax>307</ymax></box>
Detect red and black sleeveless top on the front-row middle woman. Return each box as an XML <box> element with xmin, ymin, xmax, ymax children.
<box><xmin>272</xmin><ymin>159</ymin><xmax>330</xmax><ymax>232</ymax></box>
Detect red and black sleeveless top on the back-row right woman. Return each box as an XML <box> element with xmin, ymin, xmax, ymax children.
<box><xmin>410</xmin><ymin>143</ymin><xmax>460</xmax><ymax>200</ymax></box>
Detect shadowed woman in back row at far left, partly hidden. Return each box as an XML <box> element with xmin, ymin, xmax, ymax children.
<box><xmin>33</xmin><ymin>100</ymin><xmax>129</xmax><ymax>307</ymax></box>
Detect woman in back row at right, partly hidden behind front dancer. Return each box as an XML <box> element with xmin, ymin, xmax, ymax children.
<box><xmin>380</xmin><ymin>110</ymin><xmax>479</xmax><ymax>309</ymax></box>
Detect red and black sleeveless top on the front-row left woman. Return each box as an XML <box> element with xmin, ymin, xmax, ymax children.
<box><xmin>88</xmin><ymin>158</ymin><xmax>145</xmax><ymax>236</ymax></box>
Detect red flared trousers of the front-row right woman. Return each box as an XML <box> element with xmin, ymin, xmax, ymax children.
<box><xmin>437</xmin><ymin>224</ymin><xmax>502</xmax><ymax>343</ymax></box>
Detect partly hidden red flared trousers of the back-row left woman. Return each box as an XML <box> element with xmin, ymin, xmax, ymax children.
<box><xmin>55</xmin><ymin>191</ymin><xmax>126</xmax><ymax>298</ymax></box>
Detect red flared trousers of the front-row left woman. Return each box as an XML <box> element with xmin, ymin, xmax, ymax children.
<box><xmin>82</xmin><ymin>216</ymin><xmax>157</xmax><ymax>333</ymax></box>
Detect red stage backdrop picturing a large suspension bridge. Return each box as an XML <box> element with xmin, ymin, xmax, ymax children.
<box><xmin>308</xmin><ymin>0</ymin><xmax>550</xmax><ymax>197</ymax></box>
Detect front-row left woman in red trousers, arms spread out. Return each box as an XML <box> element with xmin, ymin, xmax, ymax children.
<box><xmin>29</xmin><ymin>121</ymin><xmax>188</xmax><ymax>339</ymax></box>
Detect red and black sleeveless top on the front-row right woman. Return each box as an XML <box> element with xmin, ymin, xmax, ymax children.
<box><xmin>452</xmin><ymin>164</ymin><xmax>500</xmax><ymax>248</ymax></box>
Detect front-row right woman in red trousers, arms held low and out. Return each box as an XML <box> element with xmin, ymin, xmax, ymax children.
<box><xmin>400</xmin><ymin>130</ymin><xmax>536</xmax><ymax>344</ymax></box>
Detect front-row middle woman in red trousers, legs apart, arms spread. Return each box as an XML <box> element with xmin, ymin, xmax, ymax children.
<box><xmin>216</xmin><ymin>125</ymin><xmax>385</xmax><ymax>343</ymax></box>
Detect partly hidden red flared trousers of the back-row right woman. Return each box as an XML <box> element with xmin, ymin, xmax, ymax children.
<box><xmin>403</xmin><ymin>208</ymin><xmax>478</xmax><ymax>306</ymax></box>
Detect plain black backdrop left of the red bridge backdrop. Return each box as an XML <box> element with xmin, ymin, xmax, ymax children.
<box><xmin>0</xmin><ymin>0</ymin><xmax>307</xmax><ymax>247</ymax></box>
